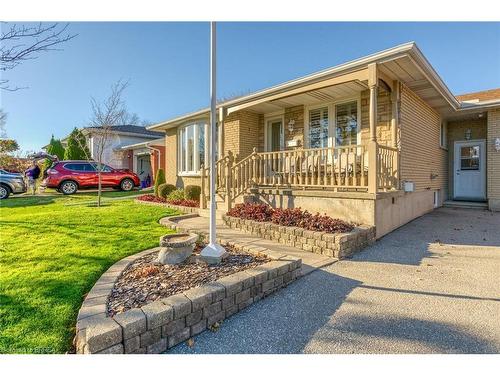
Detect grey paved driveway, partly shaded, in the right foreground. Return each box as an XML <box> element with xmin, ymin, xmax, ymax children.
<box><xmin>169</xmin><ymin>208</ymin><xmax>500</xmax><ymax>353</ymax></box>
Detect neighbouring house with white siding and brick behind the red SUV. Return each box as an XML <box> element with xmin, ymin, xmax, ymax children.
<box><xmin>44</xmin><ymin>125</ymin><xmax>164</xmax><ymax>186</ymax></box>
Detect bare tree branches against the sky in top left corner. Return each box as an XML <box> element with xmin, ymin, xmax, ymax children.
<box><xmin>0</xmin><ymin>22</ymin><xmax>77</xmax><ymax>91</ymax></box>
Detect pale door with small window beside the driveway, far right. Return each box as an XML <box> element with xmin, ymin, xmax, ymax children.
<box><xmin>453</xmin><ymin>141</ymin><xmax>486</xmax><ymax>200</ymax></box>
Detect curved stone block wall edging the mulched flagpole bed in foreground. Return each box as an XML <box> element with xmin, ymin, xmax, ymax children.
<box><xmin>75</xmin><ymin>243</ymin><xmax>302</xmax><ymax>354</ymax></box>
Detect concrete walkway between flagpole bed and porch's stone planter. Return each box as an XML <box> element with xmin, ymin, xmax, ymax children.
<box><xmin>168</xmin><ymin>217</ymin><xmax>337</xmax><ymax>275</ymax></box>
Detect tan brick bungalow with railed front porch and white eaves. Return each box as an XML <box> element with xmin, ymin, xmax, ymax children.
<box><xmin>148</xmin><ymin>43</ymin><xmax>500</xmax><ymax>237</ymax></box>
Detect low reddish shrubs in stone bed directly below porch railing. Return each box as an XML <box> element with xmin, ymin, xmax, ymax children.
<box><xmin>227</xmin><ymin>203</ymin><xmax>354</xmax><ymax>233</ymax></box>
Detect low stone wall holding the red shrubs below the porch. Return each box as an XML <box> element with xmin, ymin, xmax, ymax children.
<box><xmin>222</xmin><ymin>215</ymin><xmax>375</xmax><ymax>259</ymax></box>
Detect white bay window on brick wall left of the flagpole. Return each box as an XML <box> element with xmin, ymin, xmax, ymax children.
<box><xmin>179</xmin><ymin>123</ymin><xmax>207</xmax><ymax>173</ymax></box>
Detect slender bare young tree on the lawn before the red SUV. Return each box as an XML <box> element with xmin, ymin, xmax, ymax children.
<box><xmin>88</xmin><ymin>81</ymin><xmax>128</xmax><ymax>207</ymax></box>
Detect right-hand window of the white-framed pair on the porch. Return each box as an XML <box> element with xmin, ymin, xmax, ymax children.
<box><xmin>335</xmin><ymin>101</ymin><xmax>358</xmax><ymax>146</ymax></box>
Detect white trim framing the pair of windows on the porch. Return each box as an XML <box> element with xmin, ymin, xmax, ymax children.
<box><xmin>304</xmin><ymin>92</ymin><xmax>362</xmax><ymax>148</ymax></box>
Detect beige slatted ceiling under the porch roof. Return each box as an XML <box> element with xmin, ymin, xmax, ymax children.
<box><xmin>243</xmin><ymin>80</ymin><xmax>368</xmax><ymax>113</ymax></box>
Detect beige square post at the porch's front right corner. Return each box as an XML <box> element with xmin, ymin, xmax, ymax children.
<box><xmin>368</xmin><ymin>63</ymin><xmax>378</xmax><ymax>194</ymax></box>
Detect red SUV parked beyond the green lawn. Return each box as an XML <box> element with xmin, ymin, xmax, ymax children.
<box><xmin>42</xmin><ymin>160</ymin><xmax>140</xmax><ymax>194</ymax></box>
